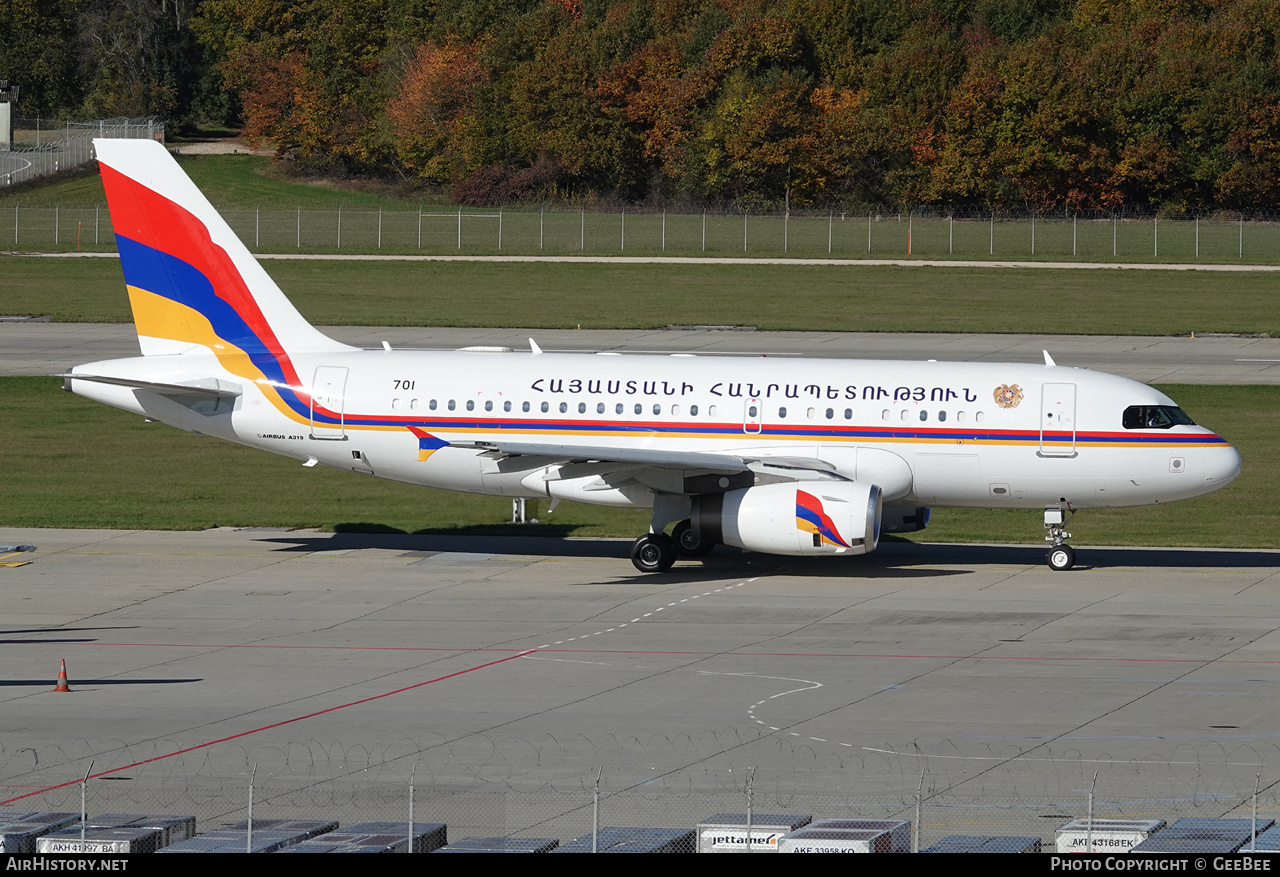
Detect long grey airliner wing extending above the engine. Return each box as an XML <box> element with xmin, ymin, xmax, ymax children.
<box><xmin>451</xmin><ymin>440</ymin><xmax>846</xmax><ymax>480</ymax></box>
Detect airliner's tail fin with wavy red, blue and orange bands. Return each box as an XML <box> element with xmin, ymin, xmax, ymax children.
<box><xmin>93</xmin><ymin>140</ymin><xmax>352</xmax><ymax>358</ymax></box>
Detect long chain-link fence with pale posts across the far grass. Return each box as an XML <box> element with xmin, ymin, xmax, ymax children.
<box><xmin>0</xmin><ymin>205</ymin><xmax>1280</xmax><ymax>265</ymax></box>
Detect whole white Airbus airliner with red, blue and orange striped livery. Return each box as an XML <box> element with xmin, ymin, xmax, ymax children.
<box><xmin>63</xmin><ymin>140</ymin><xmax>1240</xmax><ymax>572</ymax></box>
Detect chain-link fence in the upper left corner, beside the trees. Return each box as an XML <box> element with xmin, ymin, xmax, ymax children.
<box><xmin>0</xmin><ymin>117</ymin><xmax>164</xmax><ymax>189</ymax></box>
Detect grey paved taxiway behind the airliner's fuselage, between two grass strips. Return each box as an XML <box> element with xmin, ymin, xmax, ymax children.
<box><xmin>0</xmin><ymin>321</ymin><xmax>1280</xmax><ymax>384</ymax></box>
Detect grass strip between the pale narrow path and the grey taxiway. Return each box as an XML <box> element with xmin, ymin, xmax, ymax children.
<box><xmin>0</xmin><ymin>256</ymin><xmax>1280</xmax><ymax>335</ymax></box>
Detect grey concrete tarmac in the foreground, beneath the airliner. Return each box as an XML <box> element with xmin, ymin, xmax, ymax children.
<box><xmin>0</xmin><ymin>521</ymin><xmax>1280</xmax><ymax>841</ymax></box>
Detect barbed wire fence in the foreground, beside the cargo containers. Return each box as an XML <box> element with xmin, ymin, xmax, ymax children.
<box><xmin>0</xmin><ymin>730</ymin><xmax>1280</xmax><ymax>849</ymax></box>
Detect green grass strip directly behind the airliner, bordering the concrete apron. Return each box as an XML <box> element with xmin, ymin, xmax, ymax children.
<box><xmin>0</xmin><ymin>378</ymin><xmax>1280</xmax><ymax>548</ymax></box>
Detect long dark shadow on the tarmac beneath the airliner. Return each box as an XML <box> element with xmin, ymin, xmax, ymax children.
<box><xmin>262</xmin><ymin>533</ymin><xmax>1280</xmax><ymax>573</ymax></box>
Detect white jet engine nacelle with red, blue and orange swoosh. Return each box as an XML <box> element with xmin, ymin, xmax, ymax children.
<box><xmin>690</xmin><ymin>481</ymin><xmax>883</xmax><ymax>556</ymax></box>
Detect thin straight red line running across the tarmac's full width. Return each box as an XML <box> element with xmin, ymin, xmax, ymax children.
<box><xmin>17</xmin><ymin>643</ymin><xmax>1280</xmax><ymax>665</ymax></box>
